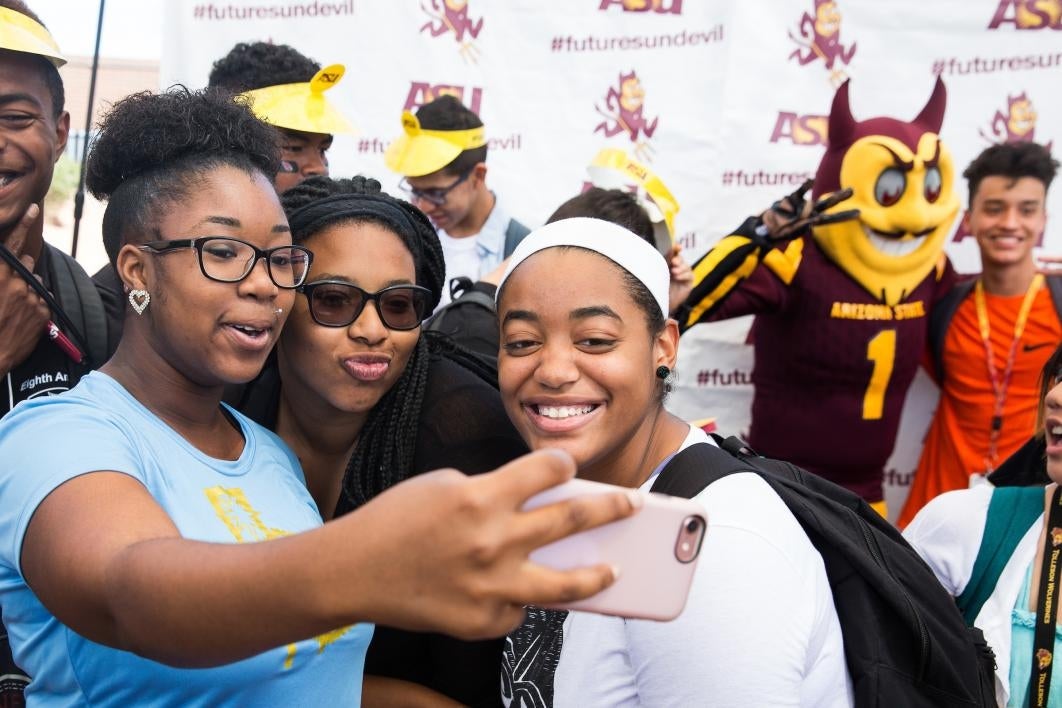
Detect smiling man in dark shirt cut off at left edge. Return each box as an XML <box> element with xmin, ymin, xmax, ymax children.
<box><xmin>0</xmin><ymin>0</ymin><xmax>122</xmax><ymax>706</ymax></box>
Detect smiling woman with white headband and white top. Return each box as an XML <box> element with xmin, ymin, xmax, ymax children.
<box><xmin>498</xmin><ymin>219</ymin><xmax>851</xmax><ymax>707</ymax></box>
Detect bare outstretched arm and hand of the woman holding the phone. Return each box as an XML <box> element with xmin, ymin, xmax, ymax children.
<box><xmin>21</xmin><ymin>451</ymin><xmax>637</xmax><ymax>667</ymax></box>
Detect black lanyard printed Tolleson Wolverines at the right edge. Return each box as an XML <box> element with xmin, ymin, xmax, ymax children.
<box><xmin>1029</xmin><ymin>487</ymin><xmax>1062</xmax><ymax>708</ymax></box>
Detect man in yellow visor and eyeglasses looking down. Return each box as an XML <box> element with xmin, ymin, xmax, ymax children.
<box><xmin>383</xmin><ymin>96</ymin><xmax>529</xmax><ymax>311</ymax></box>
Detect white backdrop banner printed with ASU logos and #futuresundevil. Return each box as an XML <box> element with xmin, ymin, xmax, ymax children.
<box><xmin>161</xmin><ymin>0</ymin><xmax>1062</xmax><ymax>520</ymax></box>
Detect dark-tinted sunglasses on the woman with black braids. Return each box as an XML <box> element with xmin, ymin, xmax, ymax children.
<box><xmin>297</xmin><ymin>280</ymin><xmax>431</xmax><ymax>331</ymax></box>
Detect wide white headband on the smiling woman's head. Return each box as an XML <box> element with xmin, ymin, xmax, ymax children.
<box><xmin>495</xmin><ymin>217</ymin><xmax>671</xmax><ymax>317</ymax></box>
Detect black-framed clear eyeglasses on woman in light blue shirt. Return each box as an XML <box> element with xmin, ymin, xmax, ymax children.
<box><xmin>138</xmin><ymin>236</ymin><xmax>313</xmax><ymax>290</ymax></box>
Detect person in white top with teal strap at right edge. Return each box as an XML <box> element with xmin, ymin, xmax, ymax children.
<box><xmin>904</xmin><ymin>347</ymin><xmax>1062</xmax><ymax>706</ymax></box>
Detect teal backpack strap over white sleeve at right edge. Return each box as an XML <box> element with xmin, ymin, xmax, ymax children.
<box><xmin>955</xmin><ymin>486</ymin><xmax>1044</xmax><ymax>626</ymax></box>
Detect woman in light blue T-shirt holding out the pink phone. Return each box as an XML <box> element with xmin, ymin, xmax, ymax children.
<box><xmin>0</xmin><ymin>89</ymin><xmax>636</xmax><ymax>706</ymax></box>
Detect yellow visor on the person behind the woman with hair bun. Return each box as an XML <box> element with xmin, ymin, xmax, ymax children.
<box><xmin>240</xmin><ymin>64</ymin><xmax>355</xmax><ymax>134</ymax></box>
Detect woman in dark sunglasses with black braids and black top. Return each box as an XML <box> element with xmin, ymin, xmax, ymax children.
<box><xmin>238</xmin><ymin>177</ymin><xmax>527</xmax><ymax>706</ymax></box>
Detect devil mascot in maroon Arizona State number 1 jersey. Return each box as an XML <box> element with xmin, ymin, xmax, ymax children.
<box><xmin>679</xmin><ymin>79</ymin><xmax>959</xmax><ymax>514</ymax></box>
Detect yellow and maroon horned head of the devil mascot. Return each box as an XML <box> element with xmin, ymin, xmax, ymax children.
<box><xmin>812</xmin><ymin>79</ymin><xmax>959</xmax><ymax>305</ymax></box>
